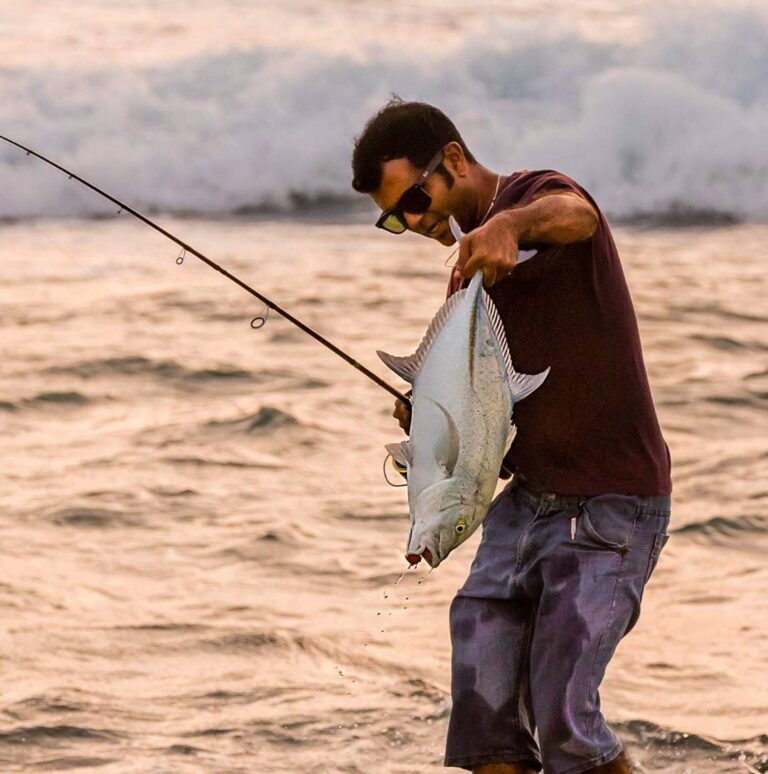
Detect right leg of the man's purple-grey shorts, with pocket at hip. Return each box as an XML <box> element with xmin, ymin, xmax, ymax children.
<box><xmin>522</xmin><ymin>495</ymin><xmax>669</xmax><ymax>774</ymax></box>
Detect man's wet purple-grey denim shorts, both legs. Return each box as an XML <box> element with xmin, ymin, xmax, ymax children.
<box><xmin>445</xmin><ymin>480</ymin><xmax>670</xmax><ymax>774</ymax></box>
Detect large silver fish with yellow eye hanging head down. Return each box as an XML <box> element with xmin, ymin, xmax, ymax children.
<box><xmin>378</xmin><ymin>221</ymin><xmax>549</xmax><ymax>567</ymax></box>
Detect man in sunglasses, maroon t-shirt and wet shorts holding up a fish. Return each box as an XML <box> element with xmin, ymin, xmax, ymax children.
<box><xmin>352</xmin><ymin>100</ymin><xmax>671</xmax><ymax>774</ymax></box>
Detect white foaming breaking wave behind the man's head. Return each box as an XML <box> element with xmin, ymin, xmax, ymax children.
<box><xmin>0</xmin><ymin>7</ymin><xmax>768</xmax><ymax>220</ymax></box>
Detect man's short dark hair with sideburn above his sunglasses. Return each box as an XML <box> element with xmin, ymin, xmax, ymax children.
<box><xmin>352</xmin><ymin>96</ymin><xmax>476</xmax><ymax>193</ymax></box>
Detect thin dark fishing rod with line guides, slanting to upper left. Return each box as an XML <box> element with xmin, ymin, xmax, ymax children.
<box><xmin>0</xmin><ymin>134</ymin><xmax>411</xmax><ymax>406</ymax></box>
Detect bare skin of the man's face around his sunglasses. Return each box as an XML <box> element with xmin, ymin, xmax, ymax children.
<box><xmin>371</xmin><ymin>158</ymin><xmax>456</xmax><ymax>245</ymax></box>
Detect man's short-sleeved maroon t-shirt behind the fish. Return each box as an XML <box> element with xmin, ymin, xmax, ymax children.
<box><xmin>451</xmin><ymin>170</ymin><xmax>672</xmax><ymax>495</ymax></box>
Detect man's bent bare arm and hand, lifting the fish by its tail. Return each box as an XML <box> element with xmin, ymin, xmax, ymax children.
<box><xmin>457</xmin><ymin>191</ymin><xmax>599</xmax><ymax>286</ymax></box>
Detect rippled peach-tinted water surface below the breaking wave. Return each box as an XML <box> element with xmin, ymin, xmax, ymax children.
<box><xmin>0</xmin><ymin>215</ymin><xmax>768</xmax><ymax>774</ymax></box>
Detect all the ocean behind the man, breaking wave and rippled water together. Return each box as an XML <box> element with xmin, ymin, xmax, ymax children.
<box><xmin>0</xmin><ymin>0</ymin><xmax>768</xmax><ymax>774</ymax></box>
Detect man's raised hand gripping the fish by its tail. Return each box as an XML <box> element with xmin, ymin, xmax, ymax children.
<box><xmin>456</xmin><ymin>218</ymin><xmax>518</xmax><ymax>287</ymax></box>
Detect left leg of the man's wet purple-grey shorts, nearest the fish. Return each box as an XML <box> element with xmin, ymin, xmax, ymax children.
<box><xmin>445</xmin><ymin>484</ymin><xmax>541</xmax><ymax>773</ymax></box>
